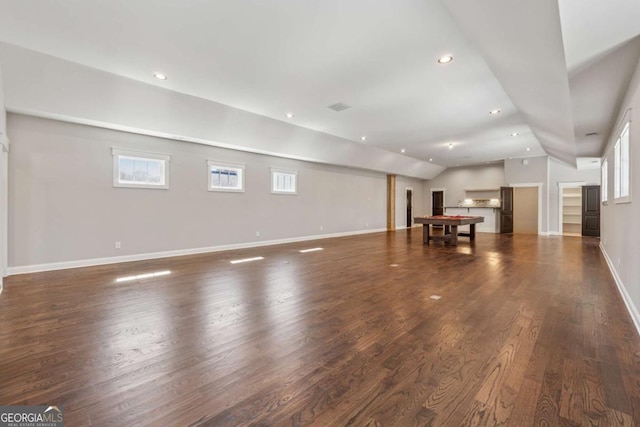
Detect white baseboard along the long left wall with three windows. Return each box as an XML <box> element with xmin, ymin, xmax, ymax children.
<box><xmin>7</xmin><ymin>228</ymin><xmax>387</xmax><ymax>276</ymax></box>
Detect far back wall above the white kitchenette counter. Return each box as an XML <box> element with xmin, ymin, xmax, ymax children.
<box><xmin>424</xmin><ymin>163</ymin><xmax>504</xmax><ymax>214</ymax></box>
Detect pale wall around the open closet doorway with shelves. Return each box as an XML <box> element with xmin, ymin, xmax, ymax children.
<box><xmin>549</xmin><ymin>158</ymin><xmax>600</xmax><ymax>234</ymax></box>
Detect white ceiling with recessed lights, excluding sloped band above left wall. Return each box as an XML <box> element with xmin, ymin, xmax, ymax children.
<box><xmin>0</xmin><ymin>0</ymin><xmax>640</xmax><ymax>171</ymax></box>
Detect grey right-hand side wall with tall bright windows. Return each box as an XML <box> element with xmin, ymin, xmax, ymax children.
<box><xmin>600</xmin><ymin>54</ymin><xmax>640</xmax><ymax>331</ymax></box>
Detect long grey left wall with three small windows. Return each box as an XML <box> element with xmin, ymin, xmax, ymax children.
<box><xmin>8</xmin><ymin>114</ymin><xmax>396</xmax><ymax>272</ymax></box>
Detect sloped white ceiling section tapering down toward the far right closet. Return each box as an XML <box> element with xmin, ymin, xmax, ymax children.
<box><xmin>444</xmin><ymin>0</ymin><xmax>576</xmax><ymax>166</ymax></box>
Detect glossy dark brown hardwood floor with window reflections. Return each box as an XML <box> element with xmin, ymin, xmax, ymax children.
<box><xmin>0</xmin><ymin>232</ymin><xmax>640</xmax><ymax>427</ymax></box>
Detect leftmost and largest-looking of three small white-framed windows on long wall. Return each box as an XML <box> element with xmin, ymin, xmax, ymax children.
<box><xmin>111</xmin><ymin>148</ymin><xmax>171</xmax><ymax>189</ymax></box>
